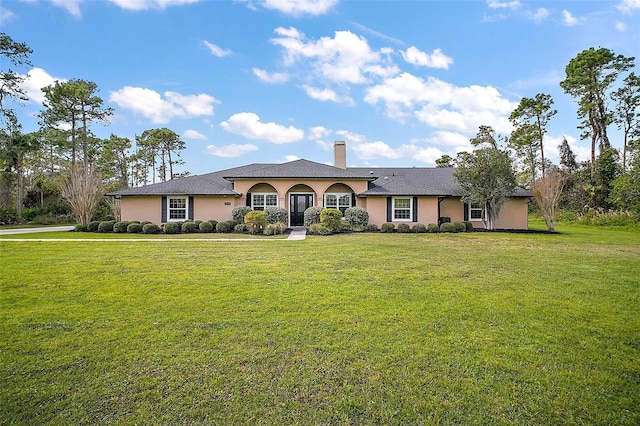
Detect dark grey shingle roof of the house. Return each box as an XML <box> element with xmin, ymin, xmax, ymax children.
<box><xmin>108</xmin><ymin>160</ymin><xmax>531</xmax><ymax>197</ymax></box>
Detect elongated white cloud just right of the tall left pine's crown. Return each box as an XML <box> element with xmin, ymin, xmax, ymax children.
<box><xmin>109</xmin><ymin>86</ymin><xmax>219</xmax><ymax>123</ymax></box>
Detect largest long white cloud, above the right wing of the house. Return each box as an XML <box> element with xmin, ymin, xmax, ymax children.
<box><xmin>364</xmin><ymin>73</ymin><xmax>517</xmax><ymax>134</ymax></box>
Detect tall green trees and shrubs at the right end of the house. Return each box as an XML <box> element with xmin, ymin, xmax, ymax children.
<box><xmin>436</xmin><ymin>48</ymin><xmax>640</xmax><ymax>230</ymax></box>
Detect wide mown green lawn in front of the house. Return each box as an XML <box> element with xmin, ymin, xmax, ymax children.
<box><xmin>0</xmin><ymin>226</ymin><xmax>640</xmax><ymax>425</ymax></box>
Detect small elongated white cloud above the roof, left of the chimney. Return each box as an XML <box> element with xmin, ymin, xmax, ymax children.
<box><xmin>220</xmin><ymin>112</ymin><xmax>304</xmax><ymax>144</ymax></box>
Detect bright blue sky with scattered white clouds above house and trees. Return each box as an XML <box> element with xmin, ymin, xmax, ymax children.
<box><xmin>0</xmin><ymin>0</ymin><xmax>640</xmax><ymax>174</ymax></box>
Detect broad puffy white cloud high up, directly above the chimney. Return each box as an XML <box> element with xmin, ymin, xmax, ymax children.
<box><xmin>271</xmin><ymin>27</ymin><xmax>398</xmax><ymax>84</ymax></box>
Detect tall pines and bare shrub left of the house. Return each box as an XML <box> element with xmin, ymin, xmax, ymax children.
<box><xmin>0</xmin><ymin>33</ymin><xmax>189</xmax><ymax>223</ymax></box>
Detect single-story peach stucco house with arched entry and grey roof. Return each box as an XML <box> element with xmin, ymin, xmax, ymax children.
<box><xmin>108</xmin><ymin>141</ymin><xmax>531</xmax><ymax>229</ymax></box>
